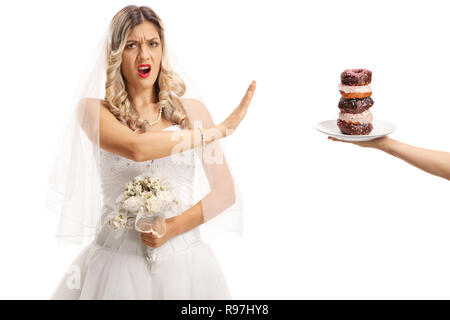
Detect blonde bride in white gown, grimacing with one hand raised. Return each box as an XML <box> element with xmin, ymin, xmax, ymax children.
<box><xmin>52</xmin><ymin>6</ymin><xmax>256</xmax><ymax>299</ymax></box>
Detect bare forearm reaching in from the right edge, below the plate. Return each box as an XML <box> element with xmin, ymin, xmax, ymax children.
<box><xmin>378</xmin><ymin>138</ymin><xmax>450</xmax><ymax>180</ymax></box>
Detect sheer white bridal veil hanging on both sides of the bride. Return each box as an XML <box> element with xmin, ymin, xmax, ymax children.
<box><xmin>46</xmin><ymin>23</ymin><xmax>243</xmax><ymax>244</ymax></box>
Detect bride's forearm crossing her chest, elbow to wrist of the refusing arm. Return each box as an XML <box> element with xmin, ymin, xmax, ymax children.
<box><xmin>133</xmin><ymin>126</ymin><xmax>223</xmax><ymax>162</ymax></box>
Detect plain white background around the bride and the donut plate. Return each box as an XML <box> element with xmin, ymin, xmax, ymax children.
<box><xmin>0</xmin><ymin>0</ymin><xmax>450</xmax><ymax>299</ymax></box>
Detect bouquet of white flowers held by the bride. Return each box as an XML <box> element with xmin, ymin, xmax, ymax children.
<box><xmin>108</xmin><ymin>174</ymin><xmax>178</xmax><ymax>272</ymax></box>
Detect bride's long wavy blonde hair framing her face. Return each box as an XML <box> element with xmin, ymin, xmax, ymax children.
<box><xmin>104</xmin><ymin>5</ymin><xmax>191</xmax><ymax>133</ymax></box>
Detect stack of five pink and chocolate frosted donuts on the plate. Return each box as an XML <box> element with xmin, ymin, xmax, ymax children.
<box><xmin>337</xmin><ymin>69</ymin><xmax>373</xmax><ymax>135</ymax></box>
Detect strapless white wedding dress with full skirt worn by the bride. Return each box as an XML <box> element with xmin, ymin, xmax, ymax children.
<box><xmin>51</xmin><ymin>126</ymin><xmax>231</xmax><ymax>299</ymax></box>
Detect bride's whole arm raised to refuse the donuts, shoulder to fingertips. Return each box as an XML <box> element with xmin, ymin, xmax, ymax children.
<box><xmin>77</xmin><ymin>82</ymin><xmax>256</xmax><ymax>161</ymax></box>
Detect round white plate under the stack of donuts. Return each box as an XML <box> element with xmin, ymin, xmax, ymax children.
<box><xmin>316</xmin><ymin>119</ymin><xmax>395</xmax><ymax>141</ymax></box>
